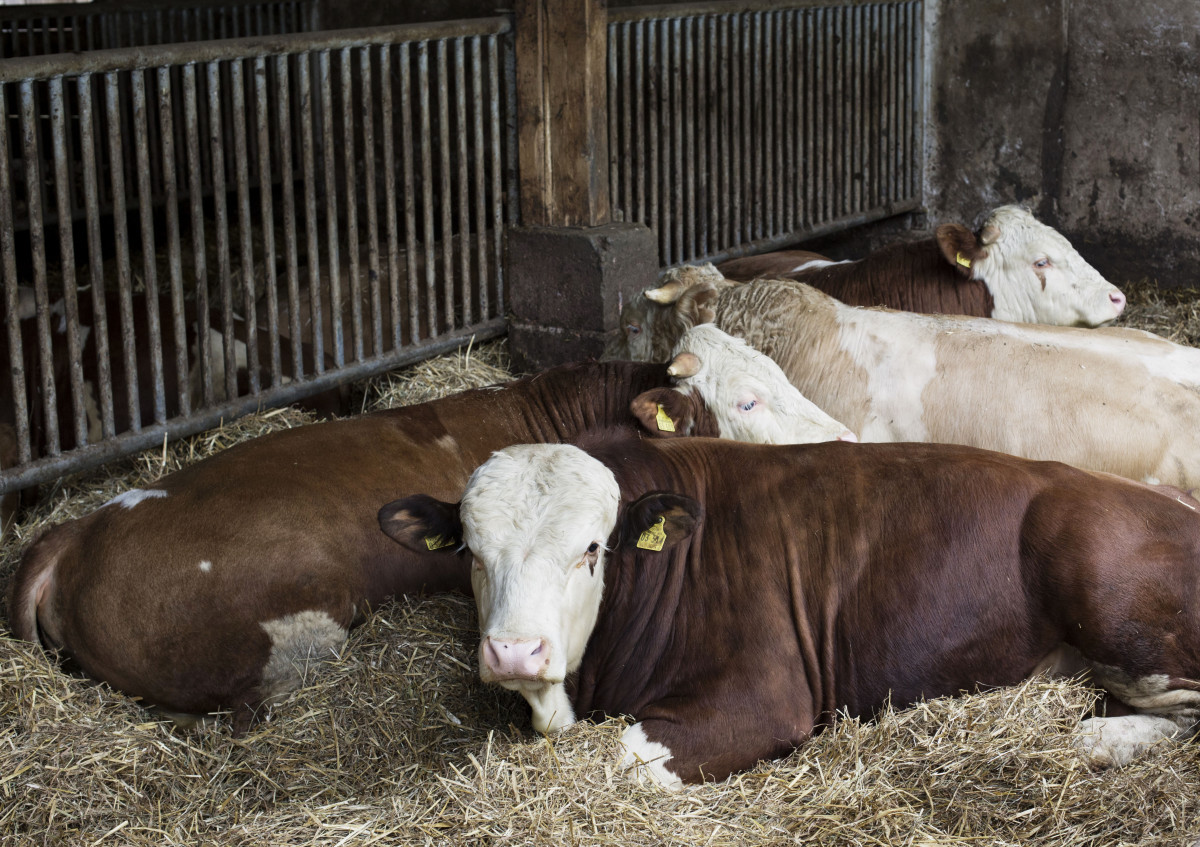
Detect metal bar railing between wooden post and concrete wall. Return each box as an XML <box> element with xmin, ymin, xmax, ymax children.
<box><xmin>608</xmin><ymin>0</ymin><xmax>923</xmax><ymax>265</ymax></box>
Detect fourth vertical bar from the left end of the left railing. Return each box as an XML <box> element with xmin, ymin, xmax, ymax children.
<box><xmin>76</xmin><ymin>73</ymin><xmax>119</xmax><ymax>438</ymax></box>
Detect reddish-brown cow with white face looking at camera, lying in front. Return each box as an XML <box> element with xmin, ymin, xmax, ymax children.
<box><xmin>380</xmin><ymin>438</ymin><xmax>1200</xmax><ymax>786</ymax></box>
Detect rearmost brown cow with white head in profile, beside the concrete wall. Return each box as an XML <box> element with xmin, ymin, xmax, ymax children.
<box><xmin>718</xmin><ymin>206</ymin><xmax>1126</xmax><ymax>326</ymax></box>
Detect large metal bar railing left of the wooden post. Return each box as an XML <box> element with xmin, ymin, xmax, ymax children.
<box><xmin>0</xmin><ymin>18</ymin><xmax>516</xmax><ymax>493</ymax></box>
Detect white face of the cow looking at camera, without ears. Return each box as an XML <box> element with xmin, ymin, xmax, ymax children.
<box><xmin>461</xmin><ymin>444</ymin><xmax>620</xmax><ymax>732</ymax></box>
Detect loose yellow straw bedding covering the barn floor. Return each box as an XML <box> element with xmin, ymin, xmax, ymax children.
<box><xmin>0</xmin><ymin>283</ymin><xmax>1200</xmax><ymax>846</ymax></box>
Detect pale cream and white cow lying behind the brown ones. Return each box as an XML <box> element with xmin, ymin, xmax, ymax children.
<box><xmin>604</xmin><ymin>271</ymin><xmax>1200</xmax><ymax>489</ymax></box>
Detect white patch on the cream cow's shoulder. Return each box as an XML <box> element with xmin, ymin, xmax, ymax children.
<box><xmin>836</xmin><ymin>306</ymin><xmax>938</xmax><ymax>441</ymax></box>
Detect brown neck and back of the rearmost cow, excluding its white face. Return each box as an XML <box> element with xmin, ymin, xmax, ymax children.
<box><xmin>718</xmin><ymin>233</ymin><xmax>995</xmax><ymax>318</ymax></box>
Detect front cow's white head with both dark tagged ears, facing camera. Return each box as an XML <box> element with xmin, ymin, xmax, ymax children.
<box><xmin>380</xmin><ymin>444</ymin><xmax>700</xmax><ymax>732</ymax></box>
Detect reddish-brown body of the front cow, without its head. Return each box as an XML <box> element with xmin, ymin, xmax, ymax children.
<box><xmin>571</xmin><ymin>439</ymin><xmax>1200</xmax><ymax>781</ymax></box>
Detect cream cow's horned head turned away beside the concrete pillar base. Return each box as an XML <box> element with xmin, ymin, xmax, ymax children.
<box><xmin>604</xmin><ymin>264</ymin><xmax>738</xmax><ymax>362</ymax></box>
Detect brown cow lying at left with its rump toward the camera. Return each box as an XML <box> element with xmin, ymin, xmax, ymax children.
<box><xmin>10</xmin><ymin>342</ymin><xmax>846</xmax><ymax>728</ymax></box>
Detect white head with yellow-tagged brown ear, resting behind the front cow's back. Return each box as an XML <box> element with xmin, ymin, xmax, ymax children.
<box><xmin>630</xmin><ymin>324</ymin><xmax>858</xmax><ymax>444</ymax></box>
